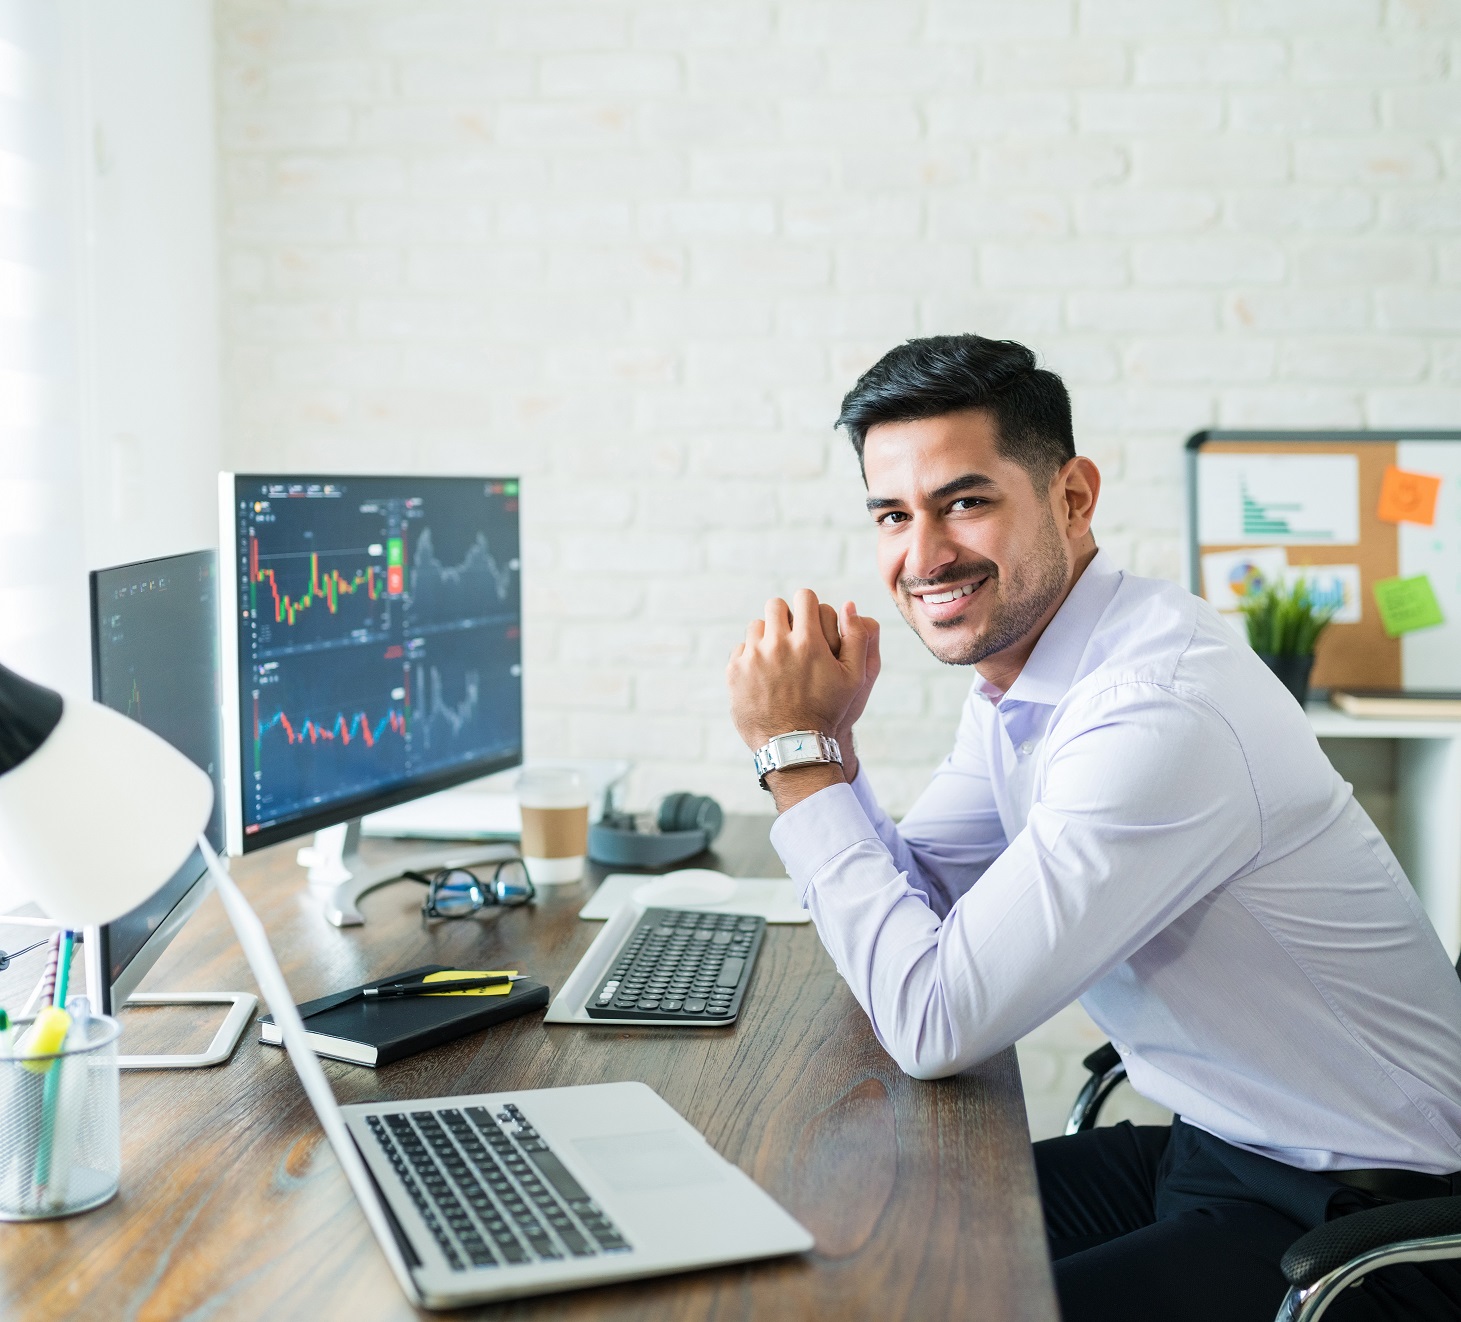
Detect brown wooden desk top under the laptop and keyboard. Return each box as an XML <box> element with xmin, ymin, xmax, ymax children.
<box><xmin>0</xmin><ymin>818</ymin><xmax>1056</xmax><ymax>1322</ymax></box>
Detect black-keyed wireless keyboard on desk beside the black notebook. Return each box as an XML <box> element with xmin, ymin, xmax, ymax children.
<box><xmin>583</xmin><ymin>909</ymin><xmax>766</xmax><ymax>1024</ymax></box>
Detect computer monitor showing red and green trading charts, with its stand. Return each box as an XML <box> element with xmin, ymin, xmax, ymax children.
<box><xmin>219</xmin><ymin>473</ymin><xmax>523</xmax><ymax>922</ymax></box>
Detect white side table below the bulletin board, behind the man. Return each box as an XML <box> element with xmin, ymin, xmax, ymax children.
<box><xmin>1306</xmin><ymin>703</ymin><xmax>1461</xmax><ymax>960</ymax></box>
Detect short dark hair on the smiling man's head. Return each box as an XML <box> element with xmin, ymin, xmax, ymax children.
<box><xmin>836</xmin><ymin>335</ymin><xmax>1075</xmax><ymax>486</ymax></box>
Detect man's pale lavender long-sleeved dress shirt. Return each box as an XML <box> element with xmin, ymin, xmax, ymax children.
<box><xmin>771</xmin><ymin>552</ymin><xmax>1461</xmax><ymax>1173</ymax></box>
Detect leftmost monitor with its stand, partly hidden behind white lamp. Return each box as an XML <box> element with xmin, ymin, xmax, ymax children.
<box><xmin>85</xmin><ymin>551</ymin><xmax>254</xmax><ymax>1066</ymax></box>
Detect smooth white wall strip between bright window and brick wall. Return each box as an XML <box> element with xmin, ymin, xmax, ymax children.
<box><xmin>85</xmin><ymin>0</ymin><xmax>221</xmax><ymax>578</ymax></box>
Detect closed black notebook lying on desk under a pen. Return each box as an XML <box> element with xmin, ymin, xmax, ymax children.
<box><xmin>259</xmin><ymin>964</ymin><xmax>548</xmax><ymax>1065</ymax></box>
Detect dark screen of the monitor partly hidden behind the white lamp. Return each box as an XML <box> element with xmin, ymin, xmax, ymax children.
<box><xmin>91</xmin><ymin>551</ymin><xmax>224</xmax><ymax>1009</ymax></box>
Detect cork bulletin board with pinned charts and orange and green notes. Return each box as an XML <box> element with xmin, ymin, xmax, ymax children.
<box><xmin>1186</xmin><ymin>431</ymin><xmax>1461</xmax><ymax>692</ymax></box>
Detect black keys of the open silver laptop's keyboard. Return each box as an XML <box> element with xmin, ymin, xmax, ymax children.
<box><xmin>365</xmin><ymin>1103</ymin><xmax>630</xmax><ymax>1271</ymax></box>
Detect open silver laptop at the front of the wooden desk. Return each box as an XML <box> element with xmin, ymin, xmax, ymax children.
<box><xmin>219</xmin><ymin>858</ymin><xmax>812</xmax><ymax>1307</ymax></box>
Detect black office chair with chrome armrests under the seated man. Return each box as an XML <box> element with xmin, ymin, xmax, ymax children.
<box><xmin>1065</xmin><ymin>960</ymin><xmax>1461</xmax><ymax>1322</ymax></box>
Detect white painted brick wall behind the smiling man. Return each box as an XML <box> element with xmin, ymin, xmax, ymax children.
<box><xmin>216</xmin><ymin>0</ymin><xmax>1461</xmax><ymax>812</ymax></box>
